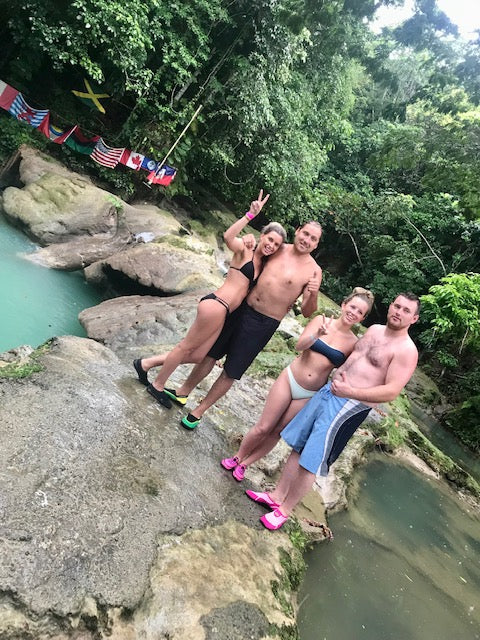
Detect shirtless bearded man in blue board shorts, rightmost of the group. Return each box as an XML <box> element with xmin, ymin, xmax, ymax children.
<box><xmin>246</xmin><ymin>293</ymin><xmax>420</xmax><ymax>530</ymax></box>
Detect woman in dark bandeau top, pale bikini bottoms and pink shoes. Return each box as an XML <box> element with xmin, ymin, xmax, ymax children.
<box><xmin>222</xmin><ymin>287</ymin><xmax>374</xmax><ymax>482</ymax></box>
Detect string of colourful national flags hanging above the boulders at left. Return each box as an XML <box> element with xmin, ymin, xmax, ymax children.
<box><xmin>0</xmin><ymin>80</ymin><xmax>177</xmax><ymax>187</ymax></box>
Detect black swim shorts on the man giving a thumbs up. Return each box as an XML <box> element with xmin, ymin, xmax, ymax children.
<box><xmin>208</xmin><ymin>302</ymin><xmax>280</xmax><ymax>380</ymax></box>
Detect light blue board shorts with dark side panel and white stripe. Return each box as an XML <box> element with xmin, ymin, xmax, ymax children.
<box><xmin>280</xmin><ymin>382</ymin><xmax>370</xmax><ymax>476</ymax></box>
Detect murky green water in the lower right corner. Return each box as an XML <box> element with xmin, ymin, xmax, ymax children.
<box><xmin>299</xmin><ymin>459</ymin><xmax>480</xmax><ymax>640</ymax></box>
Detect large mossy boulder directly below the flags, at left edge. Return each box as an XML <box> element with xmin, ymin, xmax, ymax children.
<box><xmin>0</xmin><ymin>146</ymin><xmax>181</xmax><ymax>270</ymax></box>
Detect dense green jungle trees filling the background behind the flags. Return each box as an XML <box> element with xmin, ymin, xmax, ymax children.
<box><xmin>0</xmin><ymin>0</ymin><xmax>480</xmax><ymax>444</ymax></box>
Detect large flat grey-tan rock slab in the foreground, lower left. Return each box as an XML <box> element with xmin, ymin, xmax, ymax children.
<box><xmin>0</xmin><ymin>337</ymin><xmax>300</xmax><ymax>640</ymax></box>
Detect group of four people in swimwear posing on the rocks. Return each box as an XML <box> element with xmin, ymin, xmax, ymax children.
<box><xmin>133</xmin><ymin>191</ymin><xmax>420</xmax><ymax>530</ymax></box>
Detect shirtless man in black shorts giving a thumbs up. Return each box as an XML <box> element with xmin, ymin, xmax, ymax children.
<box><xmin>169</xmin><ymin>221</ymin><xmax>322</xmax><ymax>429</ymax></box>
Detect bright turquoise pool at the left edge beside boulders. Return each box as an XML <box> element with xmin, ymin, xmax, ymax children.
<box><xmin>0</xmin><ymin>215</ymin><xmax>101</xmax><ymax>352</ymax></box>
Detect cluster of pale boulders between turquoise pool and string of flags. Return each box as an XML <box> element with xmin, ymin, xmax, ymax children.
<box><xmin>0</xmin><ymin>146</ymin><xmax>233</xmax><ymax>295</ymax></box>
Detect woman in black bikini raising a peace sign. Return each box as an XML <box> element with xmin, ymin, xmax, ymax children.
<box><xmin>133</xmin><ymin>190</ymin><xmax>287</xmax><ymax>408</ymax></box>
